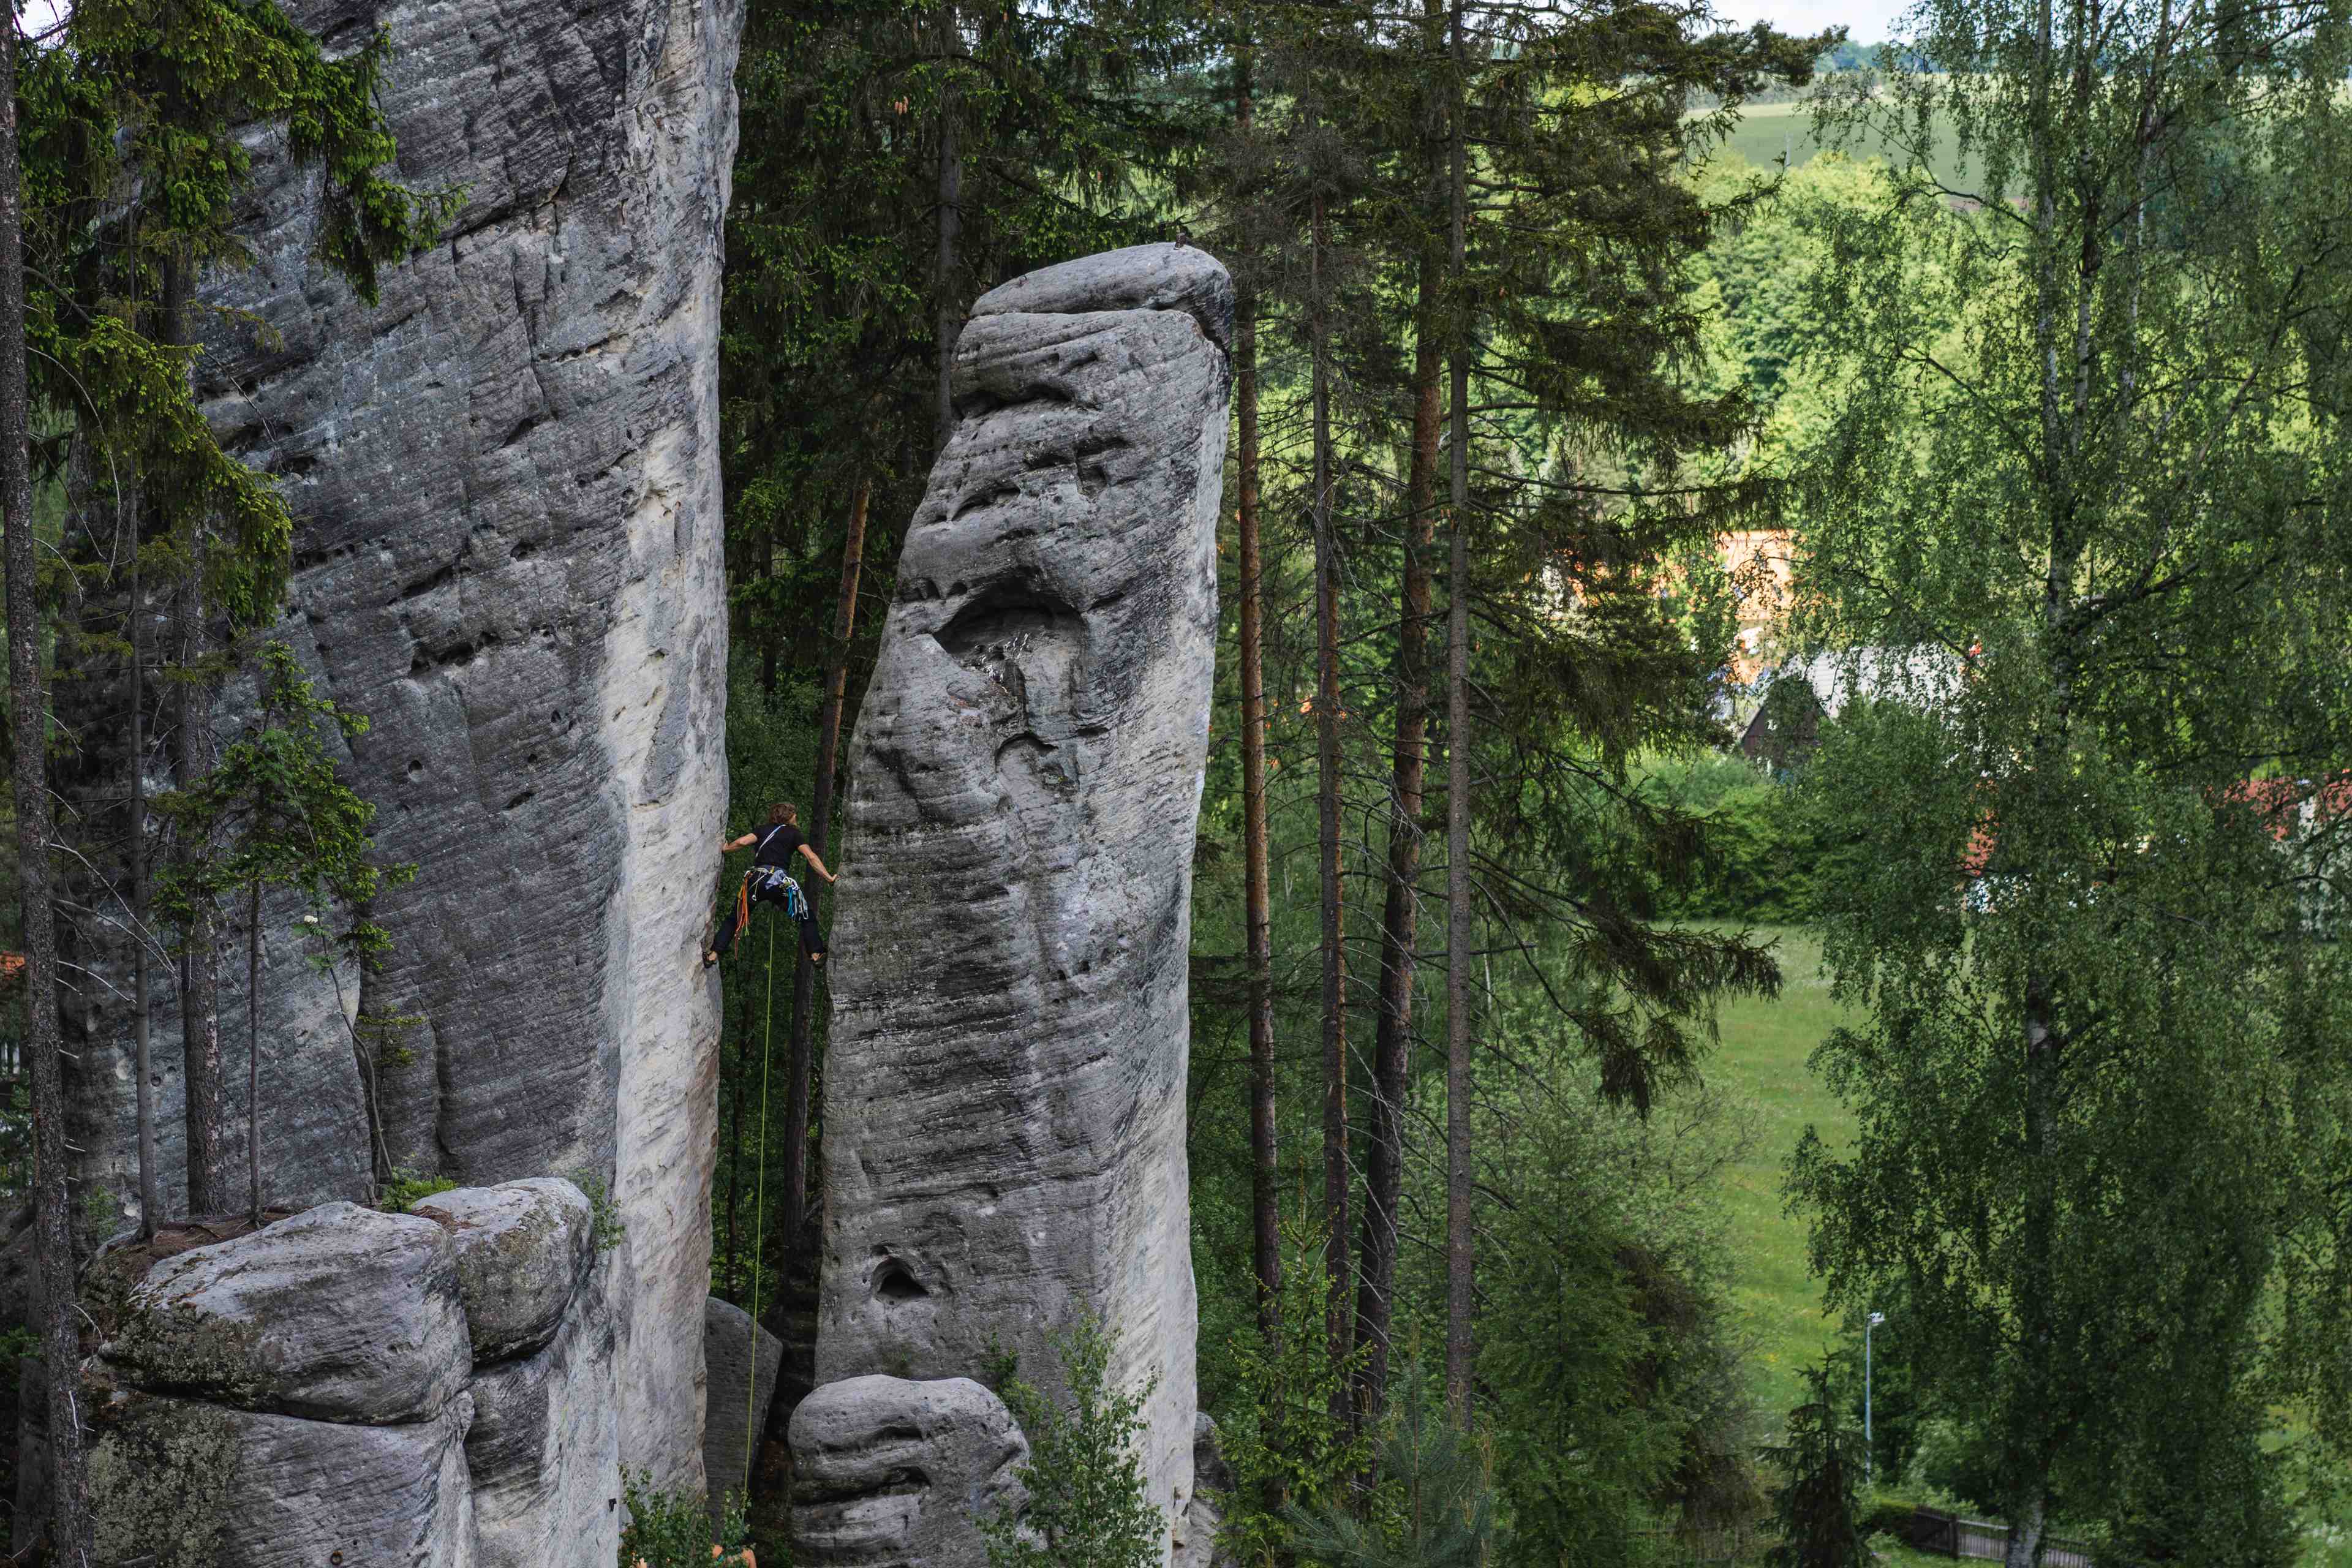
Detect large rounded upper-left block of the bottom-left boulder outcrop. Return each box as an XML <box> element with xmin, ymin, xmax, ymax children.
<box><xmin>101</xmin><ymin>1204</ymin><xmax>473</xmax><ymax>1425</ymax></box>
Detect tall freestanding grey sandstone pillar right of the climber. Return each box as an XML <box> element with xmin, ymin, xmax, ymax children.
<box><xmin>795</xmin><ymin>244</ymin><xmax>1232</xmax><ymax>1542</ymax></box>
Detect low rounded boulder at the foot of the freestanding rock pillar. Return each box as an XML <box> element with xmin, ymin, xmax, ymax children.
<box><xmin>793</xmin><ymin>1378</ymin><xmax>1028</xmax><ymax>1568</ymax></box>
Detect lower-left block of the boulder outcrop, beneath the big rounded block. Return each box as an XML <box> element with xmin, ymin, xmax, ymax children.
<box><xmin>89</xmin><ymin>1394</ymin><xmax>475</xmax><ymax>1568</ymax></box>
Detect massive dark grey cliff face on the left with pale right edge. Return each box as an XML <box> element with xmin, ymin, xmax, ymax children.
<box><xmin>55</xmin><ymin>0</ymin><xmax>743</xmax><ymax>1495</ymax></box>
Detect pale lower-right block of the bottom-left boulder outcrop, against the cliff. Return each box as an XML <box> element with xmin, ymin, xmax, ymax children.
<box><xmin>463</xmin><ymin>1270</ymin><xmax>621</xmax><ymax>1568</ymax></box>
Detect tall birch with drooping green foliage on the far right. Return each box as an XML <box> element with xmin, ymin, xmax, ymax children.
<box><xmin>1792</xmin><ymin>0</ymin><xmax>2352</xmax><ymax>1563</ymax></box>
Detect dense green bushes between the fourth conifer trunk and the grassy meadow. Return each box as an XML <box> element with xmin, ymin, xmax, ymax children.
<box><xmin>1477</xmin><ymin>1044</ymin><xmax>1759</xmax><ymax>1568</ymax></box>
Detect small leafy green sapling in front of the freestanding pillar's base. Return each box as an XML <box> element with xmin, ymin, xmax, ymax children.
<box><xmin>981</xmin><ymin>1316</ymin><xmax>1169</xmax><ymax>1568</ymax></box>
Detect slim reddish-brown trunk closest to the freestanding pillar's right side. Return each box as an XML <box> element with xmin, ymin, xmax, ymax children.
<box><xmin>1232</xmin><ymin>50</ymin><xmax>1282</xmax><ymax>1354</ymax></box>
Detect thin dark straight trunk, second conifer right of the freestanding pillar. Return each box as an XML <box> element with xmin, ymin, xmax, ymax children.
<box><xmin>1308</xmin><ymin>177</ymin><xmax>1350</xmax><ymax>1392</ymax></box>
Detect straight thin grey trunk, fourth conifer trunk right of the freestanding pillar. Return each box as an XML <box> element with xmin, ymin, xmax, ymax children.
<box><xmin>1447</xmin><ymin>0</ymin><xmax>1475</xmax><ymax>1431</ymax></box>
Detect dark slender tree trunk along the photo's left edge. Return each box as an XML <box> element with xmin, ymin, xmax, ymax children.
<box><xmin>0</xmin><ymin>19</ymin><xmax>94</xmax><ymax>1568</ymax></box>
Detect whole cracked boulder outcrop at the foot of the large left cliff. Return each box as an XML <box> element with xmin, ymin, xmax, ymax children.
<box><xmin>31</xmin><ymin>1180</ymin><xmax>621</xmax><ymax>1568</ymax></box>
